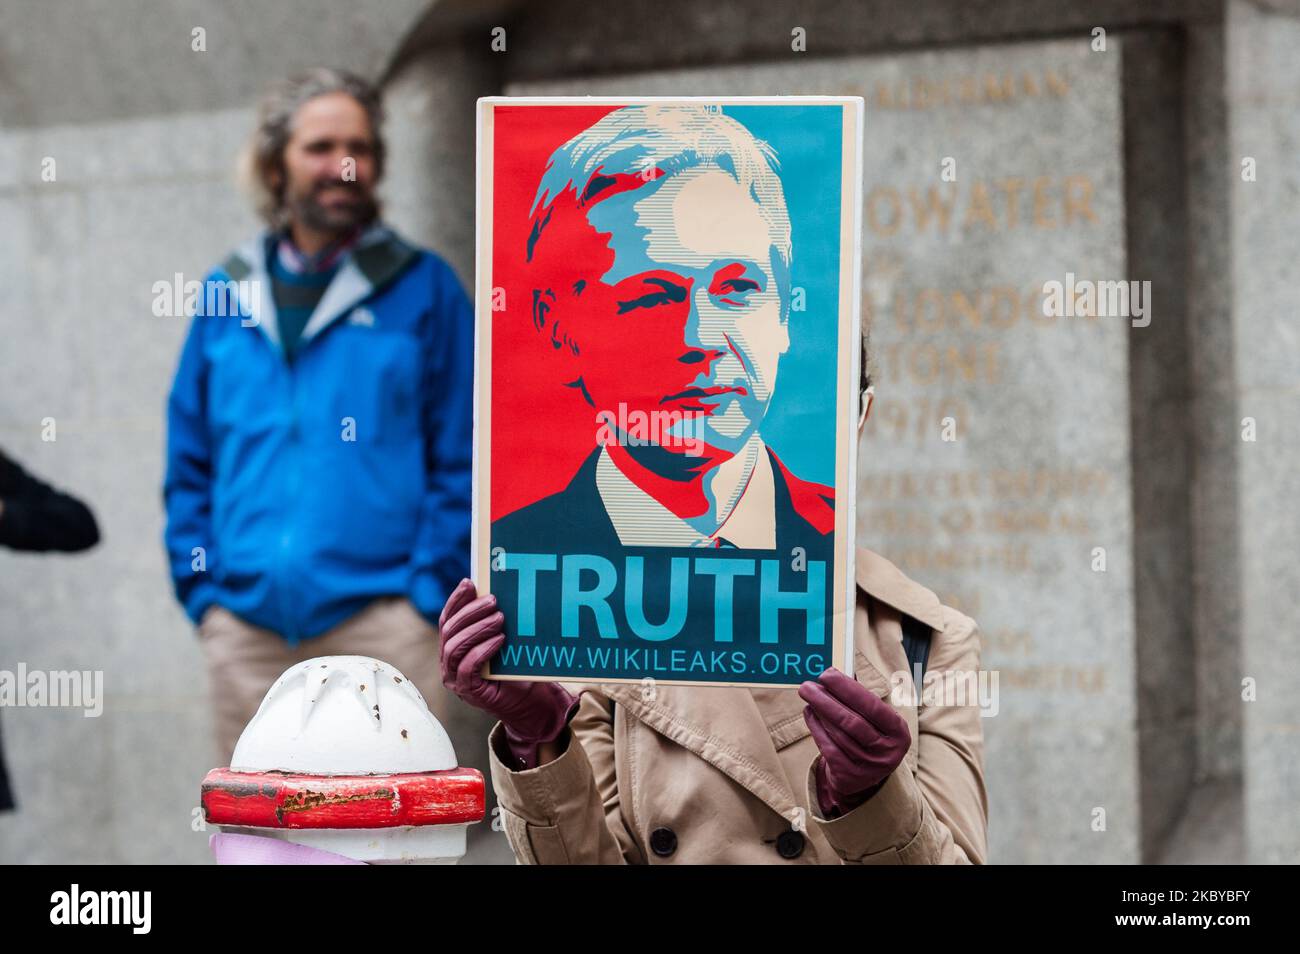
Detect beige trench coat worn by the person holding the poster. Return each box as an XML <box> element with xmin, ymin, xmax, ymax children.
<box><xmin>489</xmin><ymin>548</ymin><xmax>988</xmax><ymax>864</ymax></box>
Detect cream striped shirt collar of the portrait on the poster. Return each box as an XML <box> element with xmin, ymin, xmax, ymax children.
<box><xmin>595</xmin><ymin>434</ymin><xmax>776</xmax><ymax>550</ymax></box>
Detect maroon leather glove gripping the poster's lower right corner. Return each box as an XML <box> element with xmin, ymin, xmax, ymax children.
<box><xmin>800</xmin><ymin>668</ymin><xmax>911</xmax><ymax>818</ymax></box>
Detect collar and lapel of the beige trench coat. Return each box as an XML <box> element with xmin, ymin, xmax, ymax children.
<box><xmin>595</xmin><ymin>547</ymin><xmax>943</xmax><ymax>818</ymax></box>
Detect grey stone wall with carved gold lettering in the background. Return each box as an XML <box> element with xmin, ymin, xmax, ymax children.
<box><xmin>0</xmin><ymin>0</ymin><xmax>1300</xmax><ymax>862</ymax></box>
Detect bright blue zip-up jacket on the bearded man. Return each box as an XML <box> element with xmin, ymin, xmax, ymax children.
<box><xmin>163</xmin><ymin>226</ymin><xmax>473</xmax><ymax>645</ymax></box>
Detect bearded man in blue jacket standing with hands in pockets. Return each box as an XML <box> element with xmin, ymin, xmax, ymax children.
<box><xmin>164</xmin><ymin>69</ymin><xmax>473</xmax><ymax>764</ymax></box>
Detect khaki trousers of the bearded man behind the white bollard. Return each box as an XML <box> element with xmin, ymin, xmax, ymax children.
<box><xmin>199</xmin><ymin>597</ymin><xmax>447</xmax><ymax>766</ymax></box>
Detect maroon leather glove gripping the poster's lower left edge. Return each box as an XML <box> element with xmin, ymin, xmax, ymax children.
<box><xmin>438</xmin><ymin>580</ymin><xmax>579</xmax><ymax>769</ymax></box>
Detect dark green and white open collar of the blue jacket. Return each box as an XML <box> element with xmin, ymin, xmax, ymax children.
<box><xmin>221</xmin><ymin>222</ymin><xmax>419</xmax><ymax>350</ymax></box>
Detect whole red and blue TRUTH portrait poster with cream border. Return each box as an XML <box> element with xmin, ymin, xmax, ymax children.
<box><xmin>473</xmin><ymin>96</ymin><xmax>862</xmax><ymax>686</ymax></box>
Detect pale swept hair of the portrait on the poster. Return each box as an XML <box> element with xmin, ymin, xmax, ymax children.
<box><xmin>527</xmin><ymin>104</ymin><xmax>792</xmax><ymax>320</ymax></box>
